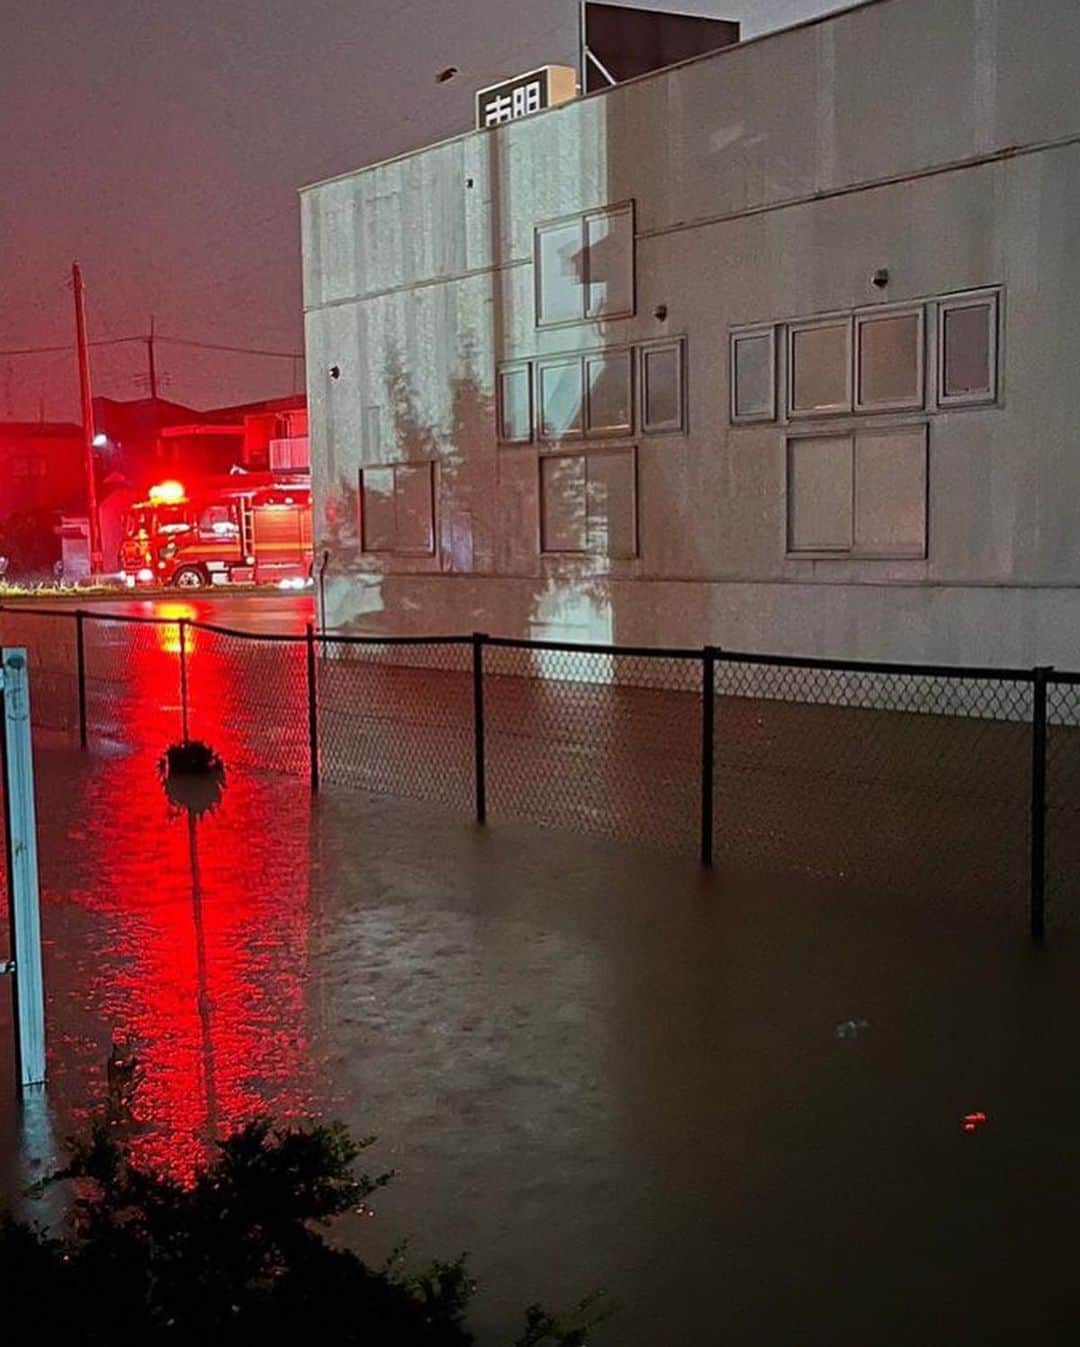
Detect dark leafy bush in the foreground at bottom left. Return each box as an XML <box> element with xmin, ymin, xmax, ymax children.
<box><xmin>0</xmin><ymin>1121</ymin><xmax>597</xmax><ymax>1347</ymax></box>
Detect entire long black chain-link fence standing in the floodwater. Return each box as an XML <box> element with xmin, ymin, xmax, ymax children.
<box><xmin>0</xmin><ymin>606</ymin><xmax>1080</xmax><ymax>938</ymax></box>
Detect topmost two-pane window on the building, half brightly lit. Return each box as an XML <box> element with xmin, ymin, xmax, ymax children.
<box><xmin>533</xmin><ymin>205</ymin><xmax>634</xmax><ymax>327</ymax></box>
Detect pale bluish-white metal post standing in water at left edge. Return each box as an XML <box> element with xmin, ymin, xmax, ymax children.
<box><xmin>3</xmin><ymin>647</ymin><xmax>44</xmax><ymax>1086</ymax></box>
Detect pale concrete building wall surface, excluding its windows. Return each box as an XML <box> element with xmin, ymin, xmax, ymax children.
<box><xmin>302</xmin><ymin>0</ymin><xmax>1080</xmax><ymax>667</ymax></box>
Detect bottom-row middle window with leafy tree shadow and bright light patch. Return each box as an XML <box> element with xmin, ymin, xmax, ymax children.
<box><xmin>540</xmin><ymin>449</ymin><xmax>637</xmax><ymax>559</ymax></box>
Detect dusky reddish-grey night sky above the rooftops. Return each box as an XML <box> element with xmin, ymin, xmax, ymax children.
<box><xmin>0</xmin><ymin>0</ymin><xmax>843</xmax><ymax>419</ymax></box>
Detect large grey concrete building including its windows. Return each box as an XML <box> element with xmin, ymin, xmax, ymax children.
<box><xmin>302</xmin><ymin>0</ymin><xmax>1080</xmax><ymax>667</ymax></box>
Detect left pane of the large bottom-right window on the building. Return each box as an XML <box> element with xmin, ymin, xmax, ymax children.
<box><xmin>788</xmin><ymin>435</ymin><xmax>854</xmax><ymax>554</ymax></box>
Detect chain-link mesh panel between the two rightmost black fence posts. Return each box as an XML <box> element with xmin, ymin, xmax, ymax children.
<box><xmin>714</xmin><ymin>659</ymin><xmax>1032</xmax><ymax>912</ymax></box>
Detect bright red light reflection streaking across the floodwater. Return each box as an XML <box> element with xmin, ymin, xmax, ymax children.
<box><xmin>66</xmin><ymin>619</ymin><xmax>312</xmax><ymax>1176</ymax></box>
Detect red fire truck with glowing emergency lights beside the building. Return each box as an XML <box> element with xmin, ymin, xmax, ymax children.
<box><xmin>120</xmin><ymin>473</ymin><xmax>311</xmax><ymax>589</ymax></box>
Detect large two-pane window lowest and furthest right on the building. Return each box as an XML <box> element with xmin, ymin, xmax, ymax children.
<box><xmin>788</xmin><ymin>426</ymin><xmax>926</xmax><ymax>558</ymax></box>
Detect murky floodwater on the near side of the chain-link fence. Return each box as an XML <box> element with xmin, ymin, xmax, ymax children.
<box><xmin>0</xmin><ymin>742</ymin><xmax>1080</xmax><ymax>1347</ymax></box>
